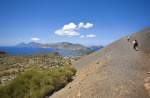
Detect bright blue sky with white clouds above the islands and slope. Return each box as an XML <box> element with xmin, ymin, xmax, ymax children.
<box><xmin>0</xmin><ymin>0</ymin><xmax>150</xmax><ymax>46</ymax></box>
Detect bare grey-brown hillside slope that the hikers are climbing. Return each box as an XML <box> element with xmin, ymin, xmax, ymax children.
<box><xmin>50</xmin><ymin>29</ymin><xmax>150</xmax><ymax>98</ymax></box>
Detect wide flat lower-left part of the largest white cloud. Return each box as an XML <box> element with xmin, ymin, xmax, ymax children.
<box><xmin>54</xmin><ymin>29</ymin><xmax>80</xmax><ymax>37</ymax></box>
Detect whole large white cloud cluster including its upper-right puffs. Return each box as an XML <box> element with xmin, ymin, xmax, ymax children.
<box><xmin>54</xmin><ymin>22</ymin><xmax>93</xmax><ymax>38</ymax></box>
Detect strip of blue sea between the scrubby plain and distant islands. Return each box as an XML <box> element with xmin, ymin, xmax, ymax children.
<box><xmin>0</xmin><ymin>47</ymin><xmax>89</xmax><ymax>56</ymax></box>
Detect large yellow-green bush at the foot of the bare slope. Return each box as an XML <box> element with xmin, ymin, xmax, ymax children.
<box><xmin>0</xmin><ymin>66</ymin><xmax>76</xmax><ymax>98</ymax></box>
